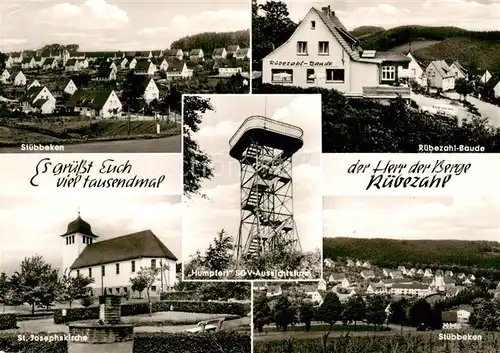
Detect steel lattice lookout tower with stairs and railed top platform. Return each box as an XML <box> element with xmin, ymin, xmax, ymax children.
<box><xmin>229</xmin><ymin>116</ymin><xmax>304</xmax><ymax>259</ymax></box>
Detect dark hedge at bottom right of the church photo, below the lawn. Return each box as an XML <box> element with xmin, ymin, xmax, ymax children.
<box><xmin>134</xmin><ymin>331</ymin><xmax>250</xmax><ymax>353</ymax></box>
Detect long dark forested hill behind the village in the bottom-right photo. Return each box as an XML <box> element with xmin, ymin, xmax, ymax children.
<box><xmin>323</xmin><ymin>238</ymin><xmax>500</xmax><ymax>270</ymax></box>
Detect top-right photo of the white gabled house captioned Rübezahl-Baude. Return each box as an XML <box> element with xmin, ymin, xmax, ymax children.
<box><xmin>252</xmin><ymin>0</ymin><xmax>500</xmax><ymax>153</ymax></box>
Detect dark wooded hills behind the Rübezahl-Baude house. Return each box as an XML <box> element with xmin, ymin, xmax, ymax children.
<box><xmin>357</xmin><ymin>25</ymin><xmax>500</xmax><ymax>71</ymax></box>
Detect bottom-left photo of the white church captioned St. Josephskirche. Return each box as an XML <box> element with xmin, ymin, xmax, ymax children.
<box><xmin>0</xmin><ymin>194</ymin><xmax>251</xmax><ymax>353</ymax></box>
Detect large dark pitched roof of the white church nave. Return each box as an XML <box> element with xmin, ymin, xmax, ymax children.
<box><xmin>71</xmin><ymin>230</ymin><xmax>177</xmax><ymax>269</ymax></box>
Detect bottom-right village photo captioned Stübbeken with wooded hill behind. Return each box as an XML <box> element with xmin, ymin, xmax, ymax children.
<box><xmin>282</xmin><ymin>194</ymin><xmax>500</xmax><ymax>353</ymax></box>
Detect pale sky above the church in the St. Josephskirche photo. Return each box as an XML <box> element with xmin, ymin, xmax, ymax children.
<box><xmin>0</xmin><ymin>195</ymin><xmax>182</xmax><ymax>274</ymax></box>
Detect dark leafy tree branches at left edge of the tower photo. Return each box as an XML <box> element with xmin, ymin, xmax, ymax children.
<box><xmin>183</xmin><ymin>96</ymin><xmax>214</xmax><ymax>197</ymax></box>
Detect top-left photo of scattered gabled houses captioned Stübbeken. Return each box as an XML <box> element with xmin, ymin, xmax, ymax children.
<box><xmin>0</xmin><ymin>0</ymin><xmax>251</xmax><ymax>153</ymax></box>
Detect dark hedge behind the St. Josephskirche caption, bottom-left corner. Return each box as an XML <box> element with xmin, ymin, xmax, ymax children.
<box><xmin>0</xmin><ymin>332</ymin><xmax>68</xmax><ymax>353</ymax></box>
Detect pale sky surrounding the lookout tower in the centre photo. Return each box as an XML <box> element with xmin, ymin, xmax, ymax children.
<box><xmin>182</xmin><ymin>95</ymin><xmax>322</xmax><ymax>261</ymax></box>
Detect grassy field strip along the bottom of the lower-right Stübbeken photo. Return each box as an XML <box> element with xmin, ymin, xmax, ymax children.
<box><xmin>254</xmin><ymin>333</ymin><xmax>500</xmax><ymax>353</ymax></box>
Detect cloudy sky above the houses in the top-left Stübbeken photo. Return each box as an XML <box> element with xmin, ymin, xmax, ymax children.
<box><xmin>0</xmin><ymin>0</ymin><xmax>251</xmax><ymax>52</ymax></box>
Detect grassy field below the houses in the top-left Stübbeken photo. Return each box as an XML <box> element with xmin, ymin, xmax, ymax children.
<box><xmin>0</xmin><ymin>118</ymin><xmax>180</xmax><ymax>147</ymax></box>
